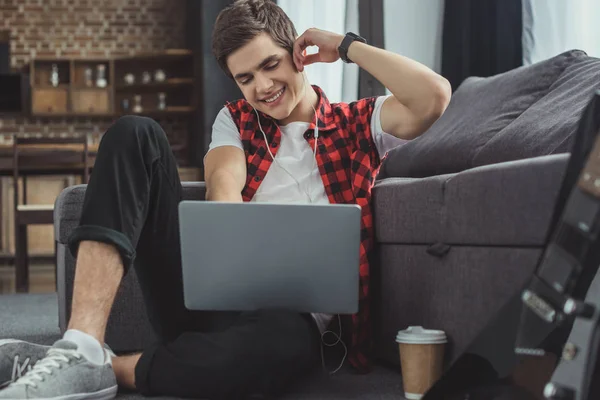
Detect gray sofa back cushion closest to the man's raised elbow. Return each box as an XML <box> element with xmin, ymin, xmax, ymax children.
<box><xmin>380</xmin><ymin>51</ymin><xmax>589</xmax><ymax>178</ymax></box>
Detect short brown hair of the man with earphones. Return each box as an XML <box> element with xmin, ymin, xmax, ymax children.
<box><xmin>212</xmin><ymin>0</ymin><xmax>298</xmax><ymax>77</ymax></box>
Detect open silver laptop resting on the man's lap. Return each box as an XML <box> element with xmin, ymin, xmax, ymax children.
<box><xmin>179</xmin><ymin>201</ymin><xmax>361</xmax><ymax>314</ymax></box>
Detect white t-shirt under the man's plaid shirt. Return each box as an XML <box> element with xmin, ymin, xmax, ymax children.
<box><xmin>208</xmin><ymin>96</ymin><xmax>405</xmax><ymax>332</ymax></box>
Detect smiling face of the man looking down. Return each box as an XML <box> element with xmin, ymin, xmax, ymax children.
<box><xmin>227</xmin><ymin>33</ymin><xmax>313</xmax><ymax>124</ymax></box>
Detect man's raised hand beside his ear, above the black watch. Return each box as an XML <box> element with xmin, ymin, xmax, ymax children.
<box><xmin>294</xmin><ymin>28</ymin><xmax>344</xmax><ymax>72</ymax></box>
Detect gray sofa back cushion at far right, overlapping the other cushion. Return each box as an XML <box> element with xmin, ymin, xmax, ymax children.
<box><xmin>473</xmin><ymin>57</ymin><xmax>600</xmax><ymax>165</ymax></box>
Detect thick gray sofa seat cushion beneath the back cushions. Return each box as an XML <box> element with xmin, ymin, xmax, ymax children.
<box><xmin>373</xmin><ymin>154</ymin><xmax>569</xmax><ymax>246</ymax></box>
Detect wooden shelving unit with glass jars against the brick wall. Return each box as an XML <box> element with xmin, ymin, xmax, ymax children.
<box><xmin>29</xmin><ymin>49</ymin><xmax>197</xmax><ymax>118</ymax></box>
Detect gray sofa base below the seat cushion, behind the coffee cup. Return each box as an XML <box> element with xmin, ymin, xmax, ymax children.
<box><xmin>373</xmin><ymin>244</ymin><xmax>542</xmax><ymax>365</ymax></box>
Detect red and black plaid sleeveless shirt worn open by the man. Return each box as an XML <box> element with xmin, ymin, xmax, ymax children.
<box><xmin>227</xmin><ymin>86</ymin><xmax>381</xmax><ymax>372</ymax></box>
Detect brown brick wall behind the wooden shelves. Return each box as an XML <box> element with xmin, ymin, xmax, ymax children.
<box><xmin>0</xmin><ymin>0</ymin><xmax>186</xmax><ymax>162</ymax></box>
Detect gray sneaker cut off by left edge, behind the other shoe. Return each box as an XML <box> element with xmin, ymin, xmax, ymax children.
<box><xmin>0</xmin><ymin>339</ymin><xmax>50</xmax><ymax>389</ymax></box>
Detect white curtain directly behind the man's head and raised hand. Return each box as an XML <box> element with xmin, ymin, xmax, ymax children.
<box><xmin>277</xmin><ymin>0</ymin><xmax>358</xmax><ymax>103</ymax></box>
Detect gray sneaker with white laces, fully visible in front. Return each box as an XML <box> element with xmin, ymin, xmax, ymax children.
<box><xmin>0</xmin><ymin>340</ymin><xmax>117</xmax><ymax>400</ymax></box>
